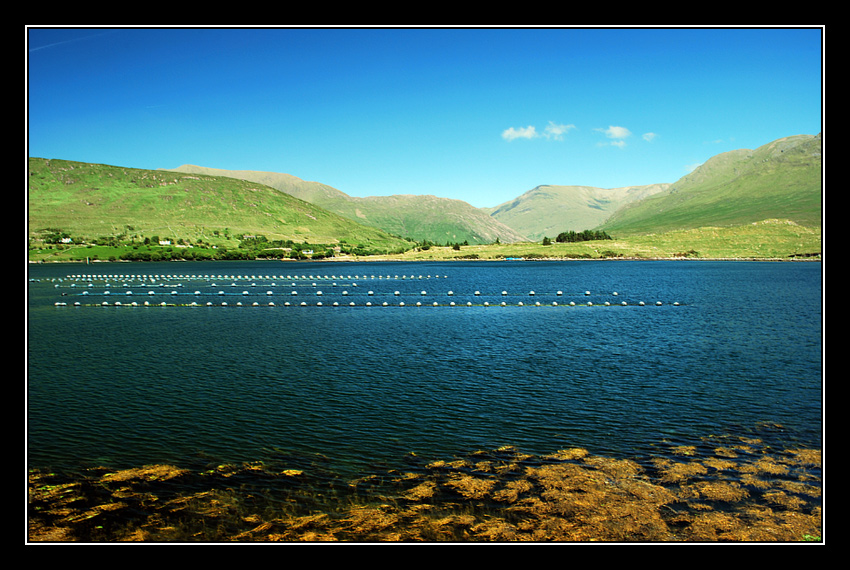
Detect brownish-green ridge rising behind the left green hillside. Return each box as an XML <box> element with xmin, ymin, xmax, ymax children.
<box><xmin>164</xmin><ymin>164</ymin><xmax>528</xmax><ymax>244</ymax></box>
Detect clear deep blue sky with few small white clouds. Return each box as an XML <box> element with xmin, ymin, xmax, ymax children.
<box><xmin>27</xmin><ymin>27</ymin><xmax>825</xmax><ymax>207</ymax></box>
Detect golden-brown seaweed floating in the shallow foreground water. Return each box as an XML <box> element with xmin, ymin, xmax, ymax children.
<box><xmin>28</xmin><ymin>430</ymin><xmax>822</xmax><ymax>542</ymax></box>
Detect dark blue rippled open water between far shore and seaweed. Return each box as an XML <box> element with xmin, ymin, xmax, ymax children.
<box><xmin>27</xmin><ymin>261</ymin><xmax>823</xmax><ymax>480</ymax></box>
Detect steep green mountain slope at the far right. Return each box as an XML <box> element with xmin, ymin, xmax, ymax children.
<box><xmin>601</xmin><ymin>135</ymin><xmax>822</xmax><ymax>236</ymax></box>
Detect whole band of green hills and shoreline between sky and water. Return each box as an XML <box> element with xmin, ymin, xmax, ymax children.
<box><xmin>28</xmin><ymin>134</ymin><xmax>823</xmax><ymax>262</ymax></box>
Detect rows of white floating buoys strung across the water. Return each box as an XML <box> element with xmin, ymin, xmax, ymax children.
<box><xmin>43</xmin><ymin>274</ymin><xmax>681</xmax><ymax>307</ymax></box>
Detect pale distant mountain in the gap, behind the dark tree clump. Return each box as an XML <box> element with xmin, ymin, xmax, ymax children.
<box><xmin>485</xmin><ymin>184</ymin><xmax>669</xmax><ymax>240</ymax></box>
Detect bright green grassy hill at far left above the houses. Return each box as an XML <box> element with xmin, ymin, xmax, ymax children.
<box><xmin>28</xmin><ymin>158</ymin><xmax>410</xmax><ymax>249</ymax></box>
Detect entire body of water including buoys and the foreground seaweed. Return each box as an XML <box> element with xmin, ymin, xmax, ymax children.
<box><xmin>28</xmin><ymin>261</ymin><xmax>821</xmax><ymax>540</ymax></box>
